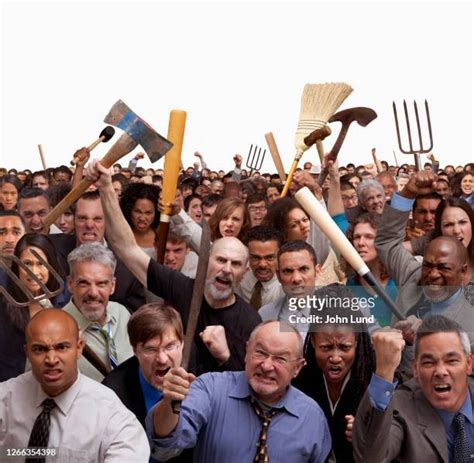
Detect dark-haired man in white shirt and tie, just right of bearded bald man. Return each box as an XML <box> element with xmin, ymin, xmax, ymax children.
<box><xmin>236</xmin><ymin>225</ymin><xmax>284</xmax><ymax>310</ymax></box>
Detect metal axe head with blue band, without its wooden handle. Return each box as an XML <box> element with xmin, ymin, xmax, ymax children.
<box><xmin>104</xmin><ymin>100</ymin><xmax>173</xmax><ymax>162</ymax></box>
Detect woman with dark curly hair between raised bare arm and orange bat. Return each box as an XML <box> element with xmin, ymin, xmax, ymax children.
<box><xmin>120</xmin><ymin>183</ymin><xmax>160</xmax><ymax>257</ymax></box>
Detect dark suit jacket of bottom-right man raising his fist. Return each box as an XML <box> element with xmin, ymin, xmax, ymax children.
<box><xmin>352</xmin><ymin>379</ymin><xmax>474</xmax><ymax>463</ymax></box>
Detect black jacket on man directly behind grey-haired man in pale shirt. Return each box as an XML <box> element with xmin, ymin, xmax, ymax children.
<box><xmin>49</xmin><ymin>233</ymin><xmax>146</xmax><ymax>312</ymax></box>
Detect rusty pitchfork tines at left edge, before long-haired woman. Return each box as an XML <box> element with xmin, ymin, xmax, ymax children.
<box><xmin>0</xmin><ymin>249</ymin><xmax>64</xmax><ymax>307</ymax></box>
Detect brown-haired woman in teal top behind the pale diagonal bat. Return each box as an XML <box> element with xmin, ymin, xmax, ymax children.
<box><xmin>346</xmin><ymin>213</ymin><xmax>397</xmax><ymax>327</ymax></box>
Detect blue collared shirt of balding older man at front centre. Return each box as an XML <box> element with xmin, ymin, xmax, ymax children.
<box><xmin>146</xmin><ymin>372</ymin><xmax>331</xmax><ymax>463</ymax></box>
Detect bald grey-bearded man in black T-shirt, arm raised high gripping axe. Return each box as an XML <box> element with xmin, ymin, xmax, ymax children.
<box><xmin>86</xmin><ymin>161</ymin><xmax>261</xmax><ymax>375</ymax></box>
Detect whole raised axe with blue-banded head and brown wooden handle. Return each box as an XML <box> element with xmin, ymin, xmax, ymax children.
<box><xmin>44</xmin><ymin>100</ymin><xmax>172</xmax><ymax>230</ymax></box>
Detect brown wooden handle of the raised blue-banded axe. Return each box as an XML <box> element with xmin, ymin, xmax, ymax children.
<box><xmin>44</xmin><ymin>133</ymin><xmax>138</xmax><ymax>230</ymax></box>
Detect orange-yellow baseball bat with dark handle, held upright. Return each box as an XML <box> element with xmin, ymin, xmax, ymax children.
<box><xmin>156</xmin><ymin>109</ymin><xmax>186</xmax><ymax>264</ymax></box>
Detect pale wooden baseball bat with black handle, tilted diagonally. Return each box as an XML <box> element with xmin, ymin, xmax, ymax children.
<box><xmin>295</xmin><ymin>187</ymin><xmax>405</xmax><ymax>320</ymax></box>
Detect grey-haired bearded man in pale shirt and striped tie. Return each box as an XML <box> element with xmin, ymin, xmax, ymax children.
<box><xmin>63</xmin><ymin>243</ymin><xmax>133</xmax><ymax>381</ymax></box>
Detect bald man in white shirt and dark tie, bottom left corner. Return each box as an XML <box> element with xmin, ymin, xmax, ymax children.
<box><xmin>0</xmin><ymin>309</ymin><xmax>150</xmax><ymax>463</ymax></box>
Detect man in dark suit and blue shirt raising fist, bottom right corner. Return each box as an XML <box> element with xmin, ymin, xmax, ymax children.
<box><xmin>352</xmin><ymin>315</ymin><xmax>474</xmax><ymax>463</ymax></box>
